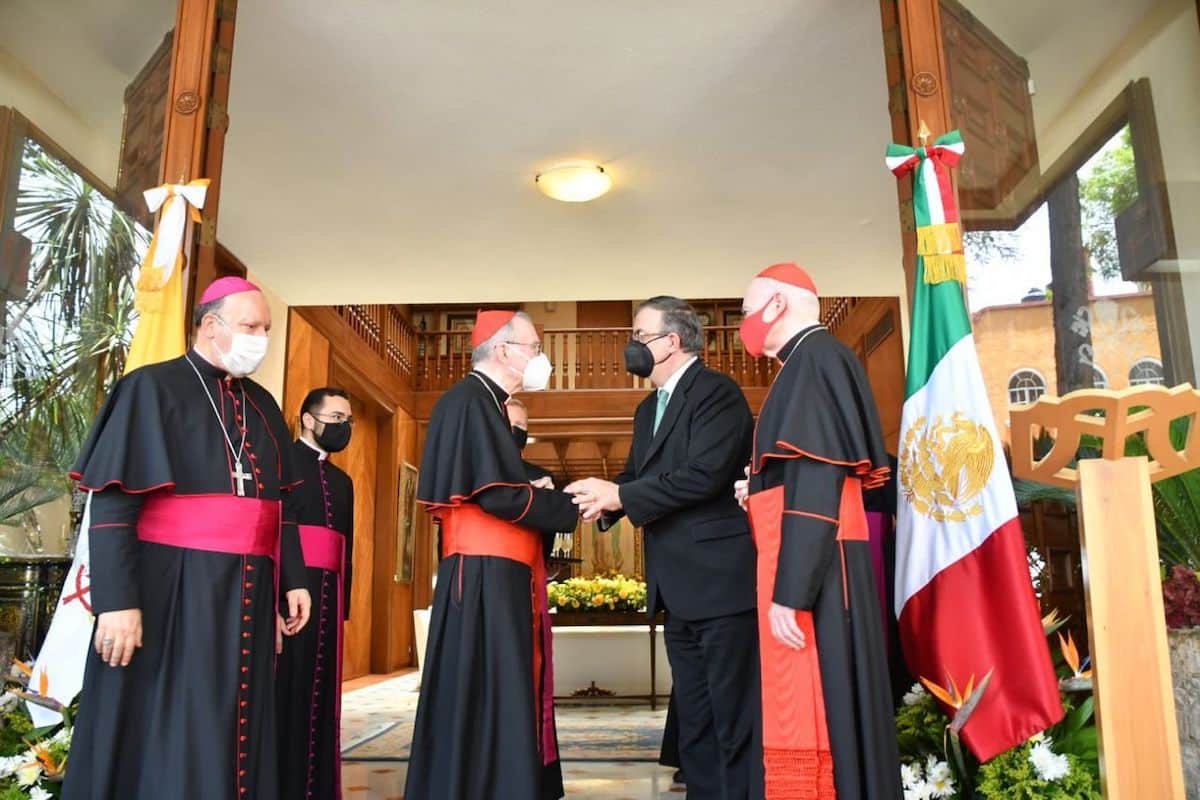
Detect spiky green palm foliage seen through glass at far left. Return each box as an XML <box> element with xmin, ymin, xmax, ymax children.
<box><xmin>0</xmin><ymin>140</ymin><xmax>149</xmax><ymax>532</ymax></box>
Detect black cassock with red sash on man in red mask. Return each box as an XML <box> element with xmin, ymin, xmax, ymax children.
<box><xmin>748</xmin><ymin>325</ymin><xmax>901</xmax><ymax>800</ymax></box>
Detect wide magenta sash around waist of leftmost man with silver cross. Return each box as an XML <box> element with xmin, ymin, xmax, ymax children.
<box><xmin>138</xmin><ymin>493</ymin><xmax>280</xmax><ymax>559</ymax></box>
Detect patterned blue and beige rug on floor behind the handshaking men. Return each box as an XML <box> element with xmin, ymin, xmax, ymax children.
<box><xmin>342</xmin><ymin>673</ymin><xmax>667</xmax><ymax>762</ymax></box>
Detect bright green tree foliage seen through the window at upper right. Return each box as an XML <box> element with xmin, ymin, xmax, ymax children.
<box><xmin>1079</xmin><ymin>126</ymin><xmax>1138</xmax><ymax>278</ymax></box>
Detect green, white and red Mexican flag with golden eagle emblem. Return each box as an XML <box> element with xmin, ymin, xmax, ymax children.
<box><xmin>887</xmin><ymin>131</ymin><xmax>1063</xmax><ymax>760</ymax></box>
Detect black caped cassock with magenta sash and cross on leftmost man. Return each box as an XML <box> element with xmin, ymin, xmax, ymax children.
<box><xmin>62</xmin><ymin>350</ymin><xmax>304</xmax><ymax>800</ymax></box>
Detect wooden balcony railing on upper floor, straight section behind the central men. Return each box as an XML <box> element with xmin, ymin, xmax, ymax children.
<box><xmin>415</xmin><ymin>326</ymin><xmax>776</xmax><ymax>391</ymax></box>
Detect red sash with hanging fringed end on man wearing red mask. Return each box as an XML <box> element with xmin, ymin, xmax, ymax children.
<box><xmin>746</xmin><ymin>477</ymin><xmax>868</xmax><ymax>800</ymax></box>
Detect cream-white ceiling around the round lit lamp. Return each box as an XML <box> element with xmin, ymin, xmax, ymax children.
<box><xmin>220</xmin><ymin>0</ymin><xmax>902</xmax><ymax>303</ymax></box>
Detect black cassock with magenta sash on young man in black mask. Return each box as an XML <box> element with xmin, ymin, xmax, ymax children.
<box><xmin>276</xmin><ymin>440</ymin><xmax>354</xmax><ymax>800</ymax></box>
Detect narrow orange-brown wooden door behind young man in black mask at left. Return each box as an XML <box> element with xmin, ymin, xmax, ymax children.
<box><xmin>334</xmin><ymin>395</ymin><xmax>379</xmax><ymax>680</ymax></box>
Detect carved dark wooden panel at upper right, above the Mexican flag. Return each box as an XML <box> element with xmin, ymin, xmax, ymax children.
<box><xmin>935</xmin><ymin>0</ymin><xmax>1040</xmax><ymax>229</ymax></box>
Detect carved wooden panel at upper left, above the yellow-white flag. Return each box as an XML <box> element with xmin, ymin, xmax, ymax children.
<box><xmin>116</xmin><ymin>34</ymin><xmax>178</xmax><ymax>228</ymax></box>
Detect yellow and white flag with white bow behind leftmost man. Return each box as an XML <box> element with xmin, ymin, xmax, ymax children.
<box><xmin>28</xmin><ymin>179</ymin><xmax>209</xmax><ymax>727</ymax></box>
